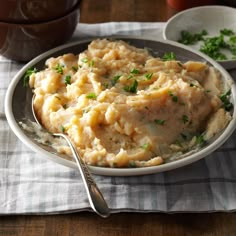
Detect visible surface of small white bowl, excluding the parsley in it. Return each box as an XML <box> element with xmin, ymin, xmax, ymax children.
<box><xmin>163</xmin><ymin>6</ymin><xmax>236</xmax><ymax>69</ymax></box>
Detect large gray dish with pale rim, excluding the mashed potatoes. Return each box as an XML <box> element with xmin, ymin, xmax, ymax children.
<box><xmin>5</xmin><ymin>36</ymin><xmax>236</xmax><ymax>176</ymax></box>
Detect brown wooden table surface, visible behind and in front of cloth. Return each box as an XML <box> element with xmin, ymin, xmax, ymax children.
<box><xmin>0</xmin><ymin>0</ymin><xmax>236</xmax><ymax>236</ymax></box>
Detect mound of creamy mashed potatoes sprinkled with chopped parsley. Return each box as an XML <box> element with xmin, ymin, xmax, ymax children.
<box><xmin>29</xmin><ymin>39</ymin><xmax>231</xmax><ymax>167</ymax></box>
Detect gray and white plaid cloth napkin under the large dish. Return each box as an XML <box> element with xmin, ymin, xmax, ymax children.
<box><xmin>0</xmin><ymin>22</ymin><xmax>236</xmax><ymax>214</ymax></box>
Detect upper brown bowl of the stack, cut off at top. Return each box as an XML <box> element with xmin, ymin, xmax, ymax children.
<box><xmin>0</xmin><ymin>0</ymin><xmax>79</xmax><ymax>23</ymax></box>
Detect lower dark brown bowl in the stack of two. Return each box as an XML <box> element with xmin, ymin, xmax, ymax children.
<box><xmin>0</xmin><ymin>3</ymin><xmax>79</xmax><ymax>62</ymax></box>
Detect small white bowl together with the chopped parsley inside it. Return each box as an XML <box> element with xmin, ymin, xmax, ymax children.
<box><xmin>163</xmin><ymin>6</ymin><xmax>236</xmax><ymax>69</ymax></box>
